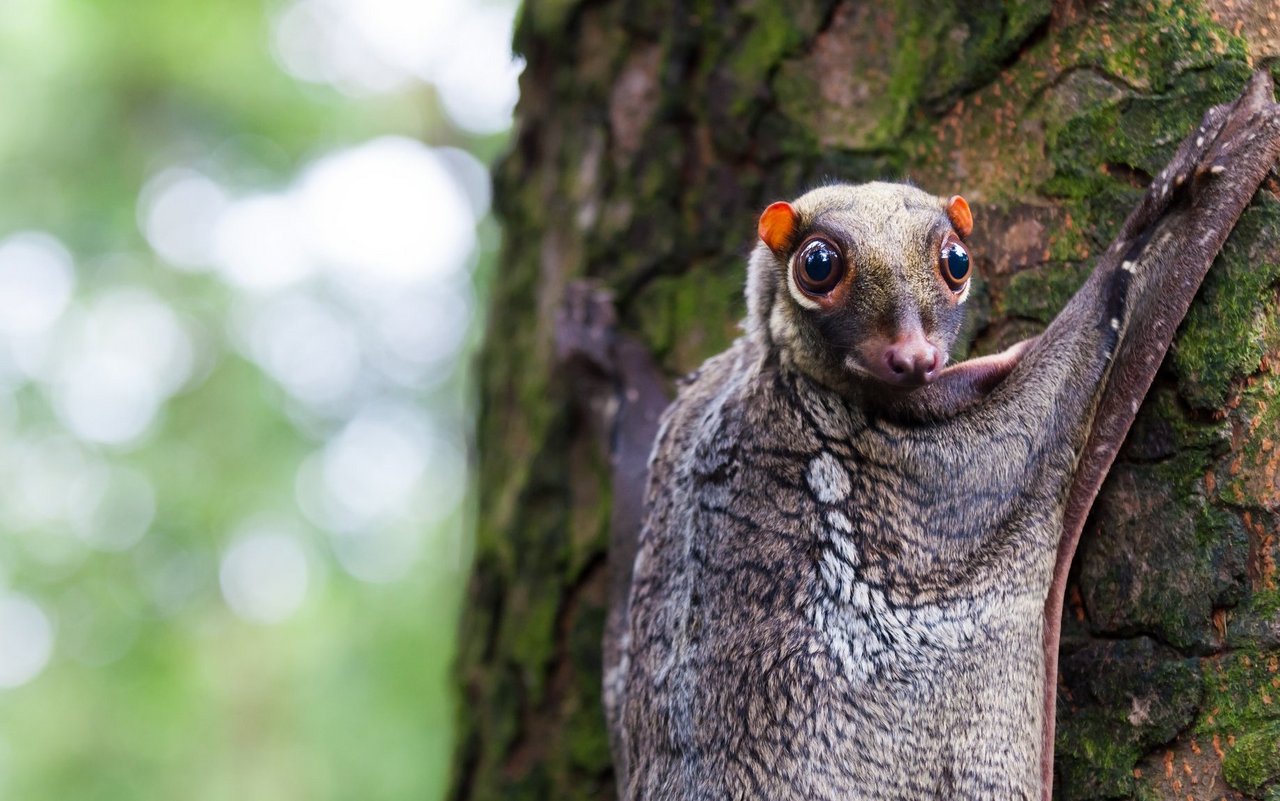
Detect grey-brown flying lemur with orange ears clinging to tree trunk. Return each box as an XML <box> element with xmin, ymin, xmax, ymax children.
<box><xmin>561</xmin><ymin>73</ymin><xmax>1280</xmax><ymax>801</ymax></box>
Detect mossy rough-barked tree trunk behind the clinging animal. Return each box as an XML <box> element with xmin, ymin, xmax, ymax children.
<box><xmin>454</xmin><ymin>0</ymin><xmax>1280</xmax><ymax>801</ymax></box>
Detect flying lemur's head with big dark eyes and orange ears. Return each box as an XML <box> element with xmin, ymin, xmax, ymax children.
<box><xmin>748</xmin><ymin>183</ymin><xmax>973</xmax><ymax>390</ymax></box>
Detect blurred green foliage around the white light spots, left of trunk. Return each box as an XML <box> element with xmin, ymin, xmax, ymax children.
<box><xmin>0</xmin><ymin>0</ymin><xmax>503</xmax><ymax>801</ymax></box>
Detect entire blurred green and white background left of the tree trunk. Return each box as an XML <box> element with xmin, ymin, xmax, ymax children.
<box><xmin>0</xmin><ymin>0</ymin><xmax>521</xmax><ymax>801</ymax></box>
